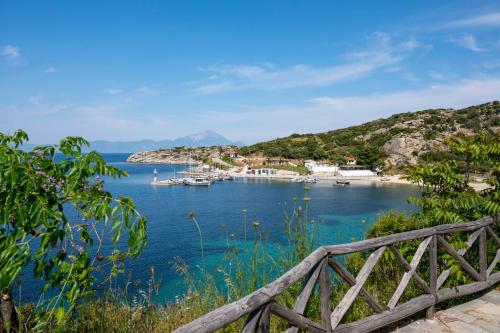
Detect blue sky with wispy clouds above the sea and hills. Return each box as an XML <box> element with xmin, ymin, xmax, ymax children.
<box><xmin>0</xmin><ymin>0</ymin><xmax>500</xmax><ymax>143</ymax></box>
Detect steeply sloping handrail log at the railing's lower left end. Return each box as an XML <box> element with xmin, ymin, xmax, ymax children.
<box><xmin>174</xmin><ymin>247</ymin><xmax>326</xmax><ymax>333</ymax></box>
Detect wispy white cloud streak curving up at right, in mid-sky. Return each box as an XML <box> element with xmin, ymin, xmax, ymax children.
<box><xmin>193</xmin><ymin>32</ymin><xmax>423</xmax><ymax>94</ymax></box>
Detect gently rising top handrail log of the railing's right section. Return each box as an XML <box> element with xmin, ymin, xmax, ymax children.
<box><xmin>325</xmin><ymin>217</ymin><xmax>500</xmax><ymax>255</ymax></box>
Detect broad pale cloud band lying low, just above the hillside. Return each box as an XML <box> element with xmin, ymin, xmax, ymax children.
<box><xmin>191</xmin><ymin>77</ymin><xmax>500</xmax><ymax>143</ymax></box>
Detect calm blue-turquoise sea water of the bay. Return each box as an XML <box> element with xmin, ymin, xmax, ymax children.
<box><xmin>17</xmin><ymin>154</ymin><xmax>419</xmax><ymax>301</ymax></box>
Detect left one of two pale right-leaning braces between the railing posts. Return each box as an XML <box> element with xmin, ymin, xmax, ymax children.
<box><xmin>331</xmin><ymin>246</ymin><xmax>386</xmax><ymax>329</ymax></box>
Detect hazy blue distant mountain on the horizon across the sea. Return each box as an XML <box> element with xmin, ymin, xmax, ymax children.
<box><xmin>23</xmin><ymin>131</ymin><xmax>243</xmax><ymax>153</ymax></box>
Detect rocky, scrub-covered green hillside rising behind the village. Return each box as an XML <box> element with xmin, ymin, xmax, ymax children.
<box><xmin>238</xmin><ymin>101</ymin><xmax>500</xmax><ymax>167</ymax></box>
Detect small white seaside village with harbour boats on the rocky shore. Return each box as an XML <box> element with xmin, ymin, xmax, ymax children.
<box><xmin>127</xmin><ymin>146</ymin><xmax>399</xmax><ymax>186</ymax></box>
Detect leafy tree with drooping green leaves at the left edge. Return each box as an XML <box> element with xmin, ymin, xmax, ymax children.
<box><xmin>0</xmin><ymin>130</ymin><xmax>147</xmax><ymax>331</ymax></box>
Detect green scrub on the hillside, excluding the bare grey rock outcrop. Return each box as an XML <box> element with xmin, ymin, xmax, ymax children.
<box><xmin>239</xmin><ymin>102</ymin><xmax>500</xmax><ymax>168</ymax></box>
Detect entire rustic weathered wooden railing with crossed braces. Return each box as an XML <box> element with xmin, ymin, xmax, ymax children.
<box><xmin>175</xmin><ymin>217</ymin><xmax>500</xmax><ymax>333</ymax></box>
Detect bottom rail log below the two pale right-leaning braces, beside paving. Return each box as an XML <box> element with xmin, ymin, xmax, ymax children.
<box><xmin>334</xmin><ymin>295</ymin><xmax>434</xmax><ymax>333</ymax></box>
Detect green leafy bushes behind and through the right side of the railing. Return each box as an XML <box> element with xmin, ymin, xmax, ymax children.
<box><xmin>332</xmin><ymin>132</ymin><xmax>500</xmax><ymax>321</ymax></box>
